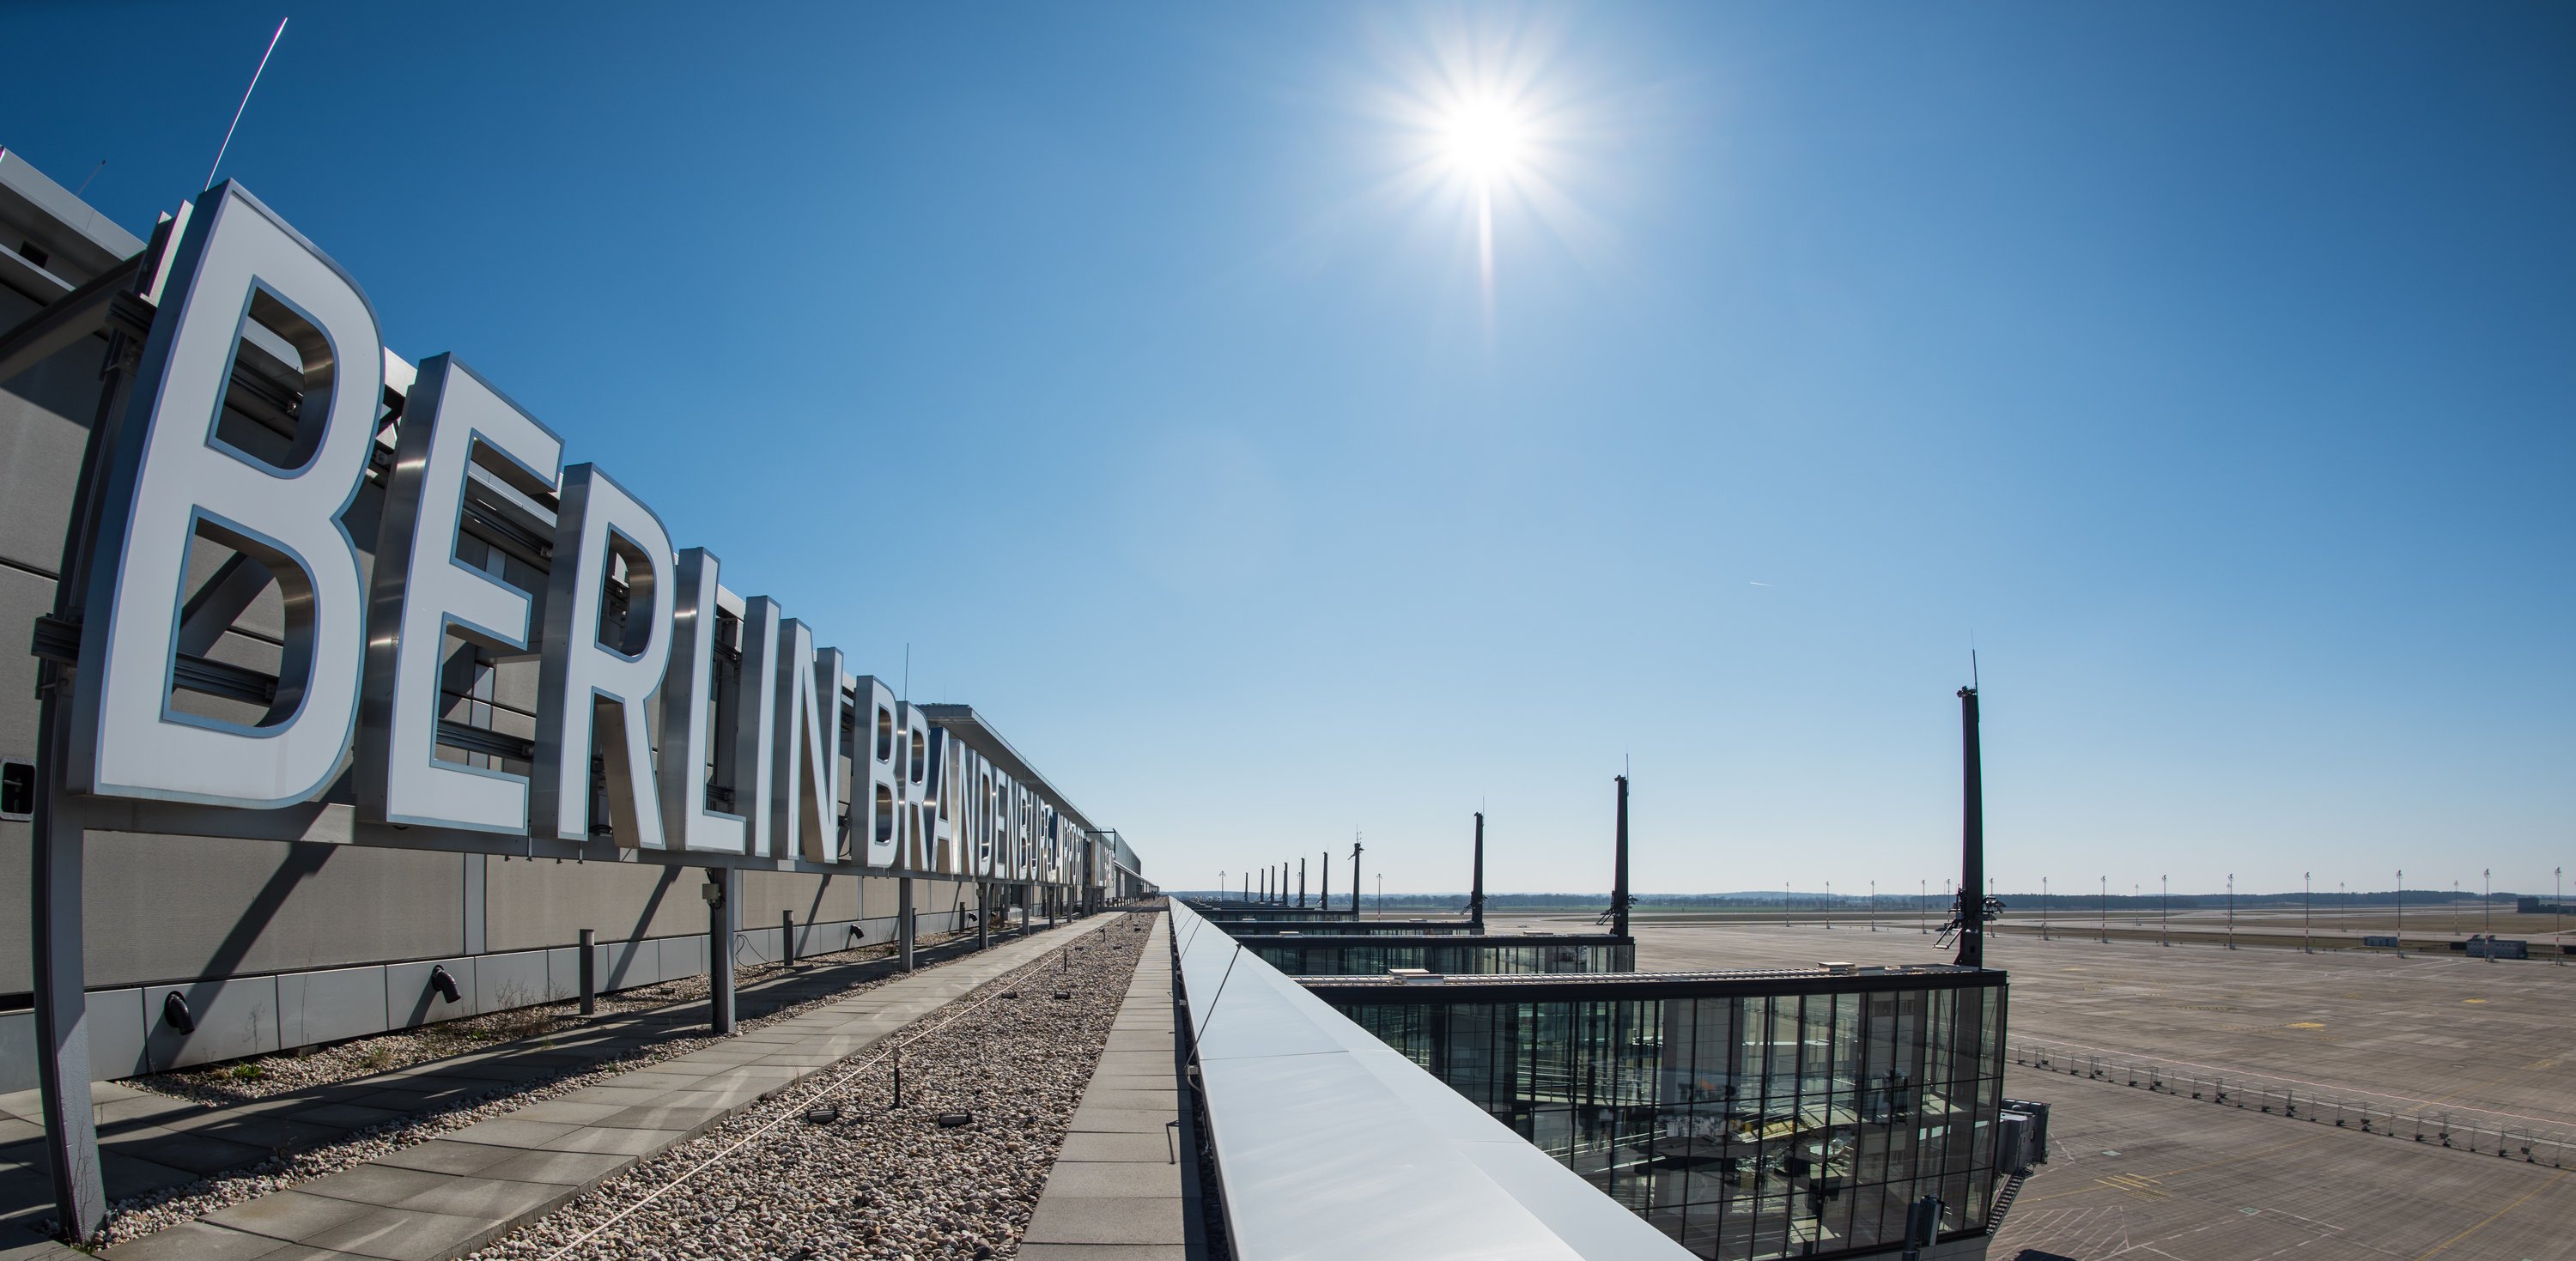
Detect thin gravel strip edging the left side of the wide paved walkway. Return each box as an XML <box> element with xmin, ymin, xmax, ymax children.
<box><xmin>70</xmin><ymin>921</ymin><xmax>1041</xmax><ymax>1248</ymax></box>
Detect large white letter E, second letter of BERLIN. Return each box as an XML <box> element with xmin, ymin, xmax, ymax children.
<box><xmin>358</xmin><ymin>355</ymin><xmax>564</xmax><ymax>836</ymax></box>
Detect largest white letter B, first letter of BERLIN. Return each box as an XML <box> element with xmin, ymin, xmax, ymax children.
<box><xmin>67</xmin><ymin>183</ymin><xmax>384</xmax><ymax>805</ymax></box>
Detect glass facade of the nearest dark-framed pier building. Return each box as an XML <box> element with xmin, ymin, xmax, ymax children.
<box><xmin>1309</xmin><ymin>970</ymin><xmax>2004</xmax><ymax>1261</ymax></box>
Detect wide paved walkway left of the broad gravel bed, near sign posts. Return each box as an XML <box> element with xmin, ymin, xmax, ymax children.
<box><xmin>5</xmin><ymin>913</ymin><xmax>1115</xmax><ymax>1261</ymax></box>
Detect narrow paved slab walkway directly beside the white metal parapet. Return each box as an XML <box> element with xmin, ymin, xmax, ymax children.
<box><xmin>1020</xmin><ymin>916</ymin><xmax>1195</xmax><ymax>1261</ymax></box>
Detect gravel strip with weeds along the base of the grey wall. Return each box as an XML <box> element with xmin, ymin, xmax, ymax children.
<box><xmin>126</xmin><ymin>929</ymin><xmax>974</xmax><ymax>1104</ymax></box>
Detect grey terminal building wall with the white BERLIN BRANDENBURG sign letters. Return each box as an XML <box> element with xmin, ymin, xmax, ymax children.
<box><xmin>0</xmin><ymin>152</ymin><xmax>1151</xmax><ymax>1091</ymax></box>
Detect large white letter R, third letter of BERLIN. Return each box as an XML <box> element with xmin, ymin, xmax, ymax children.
<box><xmin>528</xmin><ymin>464</ymin><xmax>672</xmax><ymax>849</ymax></box>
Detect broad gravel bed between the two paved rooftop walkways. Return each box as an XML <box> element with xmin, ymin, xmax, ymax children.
<box><xmin>474</xmin><ymin>918</ymin><xmax>1149</xmax><ymax>1261</ymax></box>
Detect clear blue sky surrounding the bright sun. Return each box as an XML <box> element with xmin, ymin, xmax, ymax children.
<box><xmin>0</xmin><ymin>3</ymin><xmax>2576</xmax><ymax>893</ymax></box>
